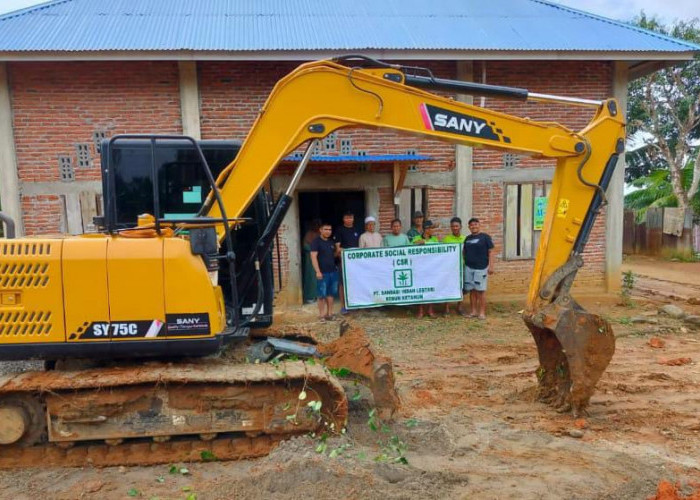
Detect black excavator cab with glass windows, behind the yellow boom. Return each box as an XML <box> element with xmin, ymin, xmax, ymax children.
<box><xmin>96</xmin><ymin>136</ymin><xmax>274</xmax><ymax>328</ymax></box>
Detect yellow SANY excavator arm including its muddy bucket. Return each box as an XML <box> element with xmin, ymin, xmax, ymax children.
<box><xmin>202</xmin><ymin>57</ymin><xmax>625</xmax><ymax>413</ymax></box>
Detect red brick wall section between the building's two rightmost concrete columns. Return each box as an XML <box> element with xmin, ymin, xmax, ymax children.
<box><xmin>472</xmin><ymin>61</ymin><xmax>612</xmax><ymax>293</ymax></box>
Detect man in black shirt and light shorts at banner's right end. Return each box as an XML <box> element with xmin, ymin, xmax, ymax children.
<box><xmin>464</xmin><ymin>217</ymin><xmax>493</xmax><ymax>319</ymax></box>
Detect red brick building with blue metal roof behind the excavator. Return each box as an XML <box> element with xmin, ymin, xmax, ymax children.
<box><xmin>0</xmin><ymin>0</ymin><xmax>700</xmax><ymax>302</ymax></box>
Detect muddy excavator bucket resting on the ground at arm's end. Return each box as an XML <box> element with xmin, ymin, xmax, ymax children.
<box><xmin>523</xmin><ymin>300</ymin><xmax>615</xmax><ymax>416</ymax></box>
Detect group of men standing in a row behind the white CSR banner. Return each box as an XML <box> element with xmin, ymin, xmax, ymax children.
<box><xmin>311</xmin><ymin>211</ymin><xmax>493</xmax><ymax>320</ymax></box>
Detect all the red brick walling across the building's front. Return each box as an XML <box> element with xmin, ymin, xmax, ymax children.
<box><xmin>9</xmin><ymin>61</ymin><xmax>612</xmax><ymax>292</ymax></box>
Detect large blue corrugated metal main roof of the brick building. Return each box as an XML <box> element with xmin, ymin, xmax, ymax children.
<box><xmin>0</xmin><ymin>0</ymin><xmax>700</xmax><ymax>53</ymax></box>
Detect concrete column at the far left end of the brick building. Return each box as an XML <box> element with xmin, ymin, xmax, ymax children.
<box><xmin>0</xmin><ymin>62</ymin><xmax>24</xmax><ymax>236</ymax></box>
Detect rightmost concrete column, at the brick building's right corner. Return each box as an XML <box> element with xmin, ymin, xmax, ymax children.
<box><xmin>605</xmin><ymin>61</ymin><xmax>628</xmax><ymax>293</ymax></box>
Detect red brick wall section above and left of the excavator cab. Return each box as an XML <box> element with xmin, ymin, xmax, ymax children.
<box><xmin>9</xmin><ymin>62</ymin><xmax>182</xmax><ymax>234</ymax></box>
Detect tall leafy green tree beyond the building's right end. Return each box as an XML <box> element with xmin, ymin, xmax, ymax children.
<box><xmin>625</xmin><ymin>13</ymin><xmax>700</xmax><ymax>213</ymax></box>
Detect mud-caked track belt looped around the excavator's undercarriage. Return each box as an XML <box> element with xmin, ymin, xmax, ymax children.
<box><xmin>0</xmin><ymin>360</ymin><xmax>348</xmax><ymax>468</ymax></box>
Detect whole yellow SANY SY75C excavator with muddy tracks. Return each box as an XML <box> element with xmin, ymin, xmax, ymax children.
<box><xmin>0</xmin><ymin>56</ymin><xmax>624</xmax><ymax>467</ymax></box>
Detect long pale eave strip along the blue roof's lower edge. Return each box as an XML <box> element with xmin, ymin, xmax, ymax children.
<box><xmin>0</xmin><ymin>49</ymin><xmax>696</xmax><ymax>62</ymax></box>
